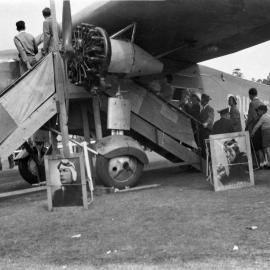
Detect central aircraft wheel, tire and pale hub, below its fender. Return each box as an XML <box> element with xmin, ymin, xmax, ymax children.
<box><xmin>96</xmin><ymin>156</ymin><xmax>143</xmax><ymax>189</ymax></box>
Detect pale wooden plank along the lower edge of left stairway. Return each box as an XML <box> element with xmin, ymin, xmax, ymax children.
<box><xmin>0</xmin><ymin>95</ymin><xmax>57</xmax><ymax>159</ymax></box>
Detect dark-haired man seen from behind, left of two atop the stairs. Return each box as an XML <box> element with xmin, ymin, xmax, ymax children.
<box><xmin>14</xmin><ymin>21</ymin><xmax>38</xmax><ymax>75</ymax></box>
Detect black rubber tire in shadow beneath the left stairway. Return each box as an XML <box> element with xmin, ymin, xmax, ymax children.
<box><xmin>18</xmin><ymin>156</ymin><xmax>45</xmax><ymax>185</ymax></box>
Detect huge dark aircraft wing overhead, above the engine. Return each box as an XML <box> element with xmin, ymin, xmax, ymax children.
<box><xmin>73</xmin><ymin>0</ymin><xmax>270</xmax><ymax>63</ymax></box>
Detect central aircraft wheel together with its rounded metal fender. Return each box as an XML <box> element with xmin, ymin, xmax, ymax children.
<box><xmin>96</xmin><ymin>135</ymin><xmax>148</xmax><ymax>189</ymax></box>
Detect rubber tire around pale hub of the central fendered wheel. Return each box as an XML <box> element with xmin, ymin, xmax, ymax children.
<box><xmin>96</xmin><ymin>156</ymin><xmax>144</xmax><ymax>189</ymax></box>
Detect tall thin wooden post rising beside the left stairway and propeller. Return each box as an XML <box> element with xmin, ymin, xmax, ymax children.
<box><xmin>50</xmin><ymin>0</ymin><xmax>70</xmax><ymax>157</ymax></box>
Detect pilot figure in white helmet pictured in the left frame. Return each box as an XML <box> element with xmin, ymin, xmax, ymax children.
<box><xmin>53</xmin><ymin>159</ymin><xmax>83</xmax><ymax>206</ymax></box>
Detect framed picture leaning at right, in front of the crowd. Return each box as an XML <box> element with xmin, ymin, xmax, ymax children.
<box><xmin>209</xmin><ymin>131</ymin><xmax>254</xmax><ymax>191</ymax></box>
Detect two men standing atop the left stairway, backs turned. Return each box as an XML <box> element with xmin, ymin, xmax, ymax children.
<box><xmin>14</xmin><ymin>8</ymin><xmax>53</xmax><ymax>75</ymax></box>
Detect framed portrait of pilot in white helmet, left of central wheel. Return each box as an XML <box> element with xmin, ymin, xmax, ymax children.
<box><xmin>45</xmin><ymin>153</ymin><xmax>88</xmax><ymax>211</ymax></box>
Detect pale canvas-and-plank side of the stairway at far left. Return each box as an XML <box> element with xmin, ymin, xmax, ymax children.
<box><xmin>0</xmin><ymin>54</ymin><xmax>57</xmax><ymax>158</ymax></box>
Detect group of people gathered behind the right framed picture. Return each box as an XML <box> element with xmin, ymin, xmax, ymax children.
<box><xmin>183</xmin><ymin>88</ymin><xmax>270</xmax><ymax>168</ymax></box>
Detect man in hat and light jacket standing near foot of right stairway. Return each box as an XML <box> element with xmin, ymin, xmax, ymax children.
<box><xmin>199</xmin><ymin>94</ymin><xmax>215</xmax><ymax>158</ymax></box>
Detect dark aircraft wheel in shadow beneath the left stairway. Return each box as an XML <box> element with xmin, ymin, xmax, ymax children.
<box><xmin>18</xmin><ymin>156</ymin><xmax>45</xmax><ymax>185</ymax></box>
